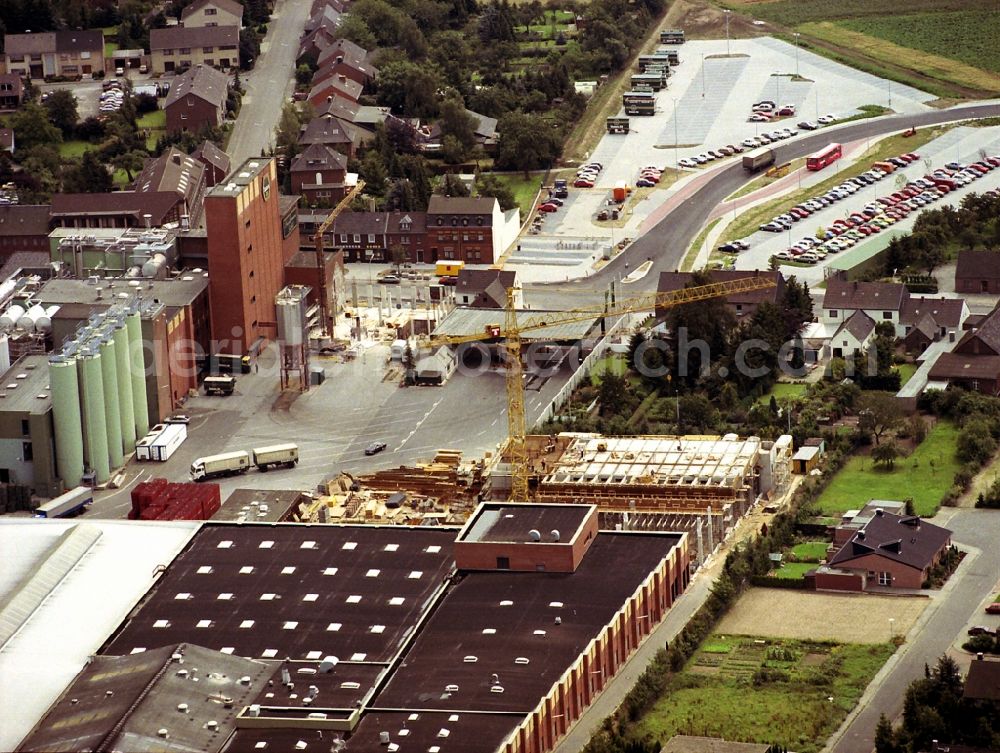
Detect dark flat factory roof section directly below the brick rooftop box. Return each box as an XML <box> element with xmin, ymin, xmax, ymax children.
<box><xmin>372</xmin><ymin>533</ymin><xmax>681</xmax><ymax>712</ymax></box>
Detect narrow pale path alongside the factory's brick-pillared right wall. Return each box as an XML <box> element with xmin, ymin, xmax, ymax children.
<box><xmin>553</xmin><ymin>478</ymin><xmax>801</xmax><ymax>753</ymax></box>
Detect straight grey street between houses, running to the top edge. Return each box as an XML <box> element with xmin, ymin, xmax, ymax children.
<box><xmin>228</xmin><ymin>0</ymin><xmax>309</xmax><ymax>167</ymax></box>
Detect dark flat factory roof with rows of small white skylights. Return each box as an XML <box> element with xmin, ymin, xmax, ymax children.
<box><xmin>102</xmin><ymin>524</ymin><xmax>455</xmax><ymax>662</ymax></box>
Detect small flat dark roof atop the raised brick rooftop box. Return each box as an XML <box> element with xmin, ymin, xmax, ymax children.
<box><xmin>460</xmin><ymin>504</ymin><xmax>593</xmax><ymax>543</ymax></box>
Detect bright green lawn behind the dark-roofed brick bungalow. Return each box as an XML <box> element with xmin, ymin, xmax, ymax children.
<box><xmin>817</xmin><ymin>421</ymin><xmax>959</xmax><ymax>516</ymax></box>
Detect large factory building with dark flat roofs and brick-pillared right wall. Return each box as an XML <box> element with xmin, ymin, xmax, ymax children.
<box><xmin>13</xmin><ymin>503</ymin><xmax>689</xmax><ymax>753</ymax></box>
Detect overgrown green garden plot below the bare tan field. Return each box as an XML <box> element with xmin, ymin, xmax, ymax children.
<box><xmin>634</xmin><ymin>635</ymin><xmax>894</xmax><ymax>753</ymax></box>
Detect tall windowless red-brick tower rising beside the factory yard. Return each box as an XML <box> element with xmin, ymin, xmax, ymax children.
<box><xmin>205</xmin><ymin>158</ymin><xmax>288</xmax><ymax>355</ymax></box>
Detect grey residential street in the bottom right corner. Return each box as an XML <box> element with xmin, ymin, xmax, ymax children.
<box><xmin>825</xmin><ymin>509</ymin><xmax>1000</xmax><ymax>753</ymax></box>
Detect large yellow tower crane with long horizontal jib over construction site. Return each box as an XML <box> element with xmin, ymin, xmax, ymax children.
<box><xmin>431</xmin><ymin>274</ymin><xmax>775</xmax><ymax>502</ymax></box>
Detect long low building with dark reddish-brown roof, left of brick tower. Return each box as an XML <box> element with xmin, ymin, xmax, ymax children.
<box><xmin>49</xmin><ymin>191</ymin><xmax>183</xmax><ymax>228</ymax></box>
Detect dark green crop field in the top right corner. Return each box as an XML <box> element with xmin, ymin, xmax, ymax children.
<box><xmin>839</xmin><ymin>10</ymin><xmax>1000</xmax><ymax>73</ymax></box>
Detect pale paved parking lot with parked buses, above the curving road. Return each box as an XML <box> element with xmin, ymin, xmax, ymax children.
<box><xmin>509</xmin><ymin>37</ymin><xmax>933</xmax><ymax>280</ymax></box>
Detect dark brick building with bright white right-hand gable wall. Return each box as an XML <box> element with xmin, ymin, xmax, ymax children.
<box><xmin>427</xmin><ymin>195</ymin><xmax>507</xmax><ymax>264</ymax></box>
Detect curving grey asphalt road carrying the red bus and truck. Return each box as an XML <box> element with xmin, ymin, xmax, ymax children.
<box><xmin>525</xmin><ymin>104</ymin><xmax>1000</xmax><ymax>307</ymax></box>
